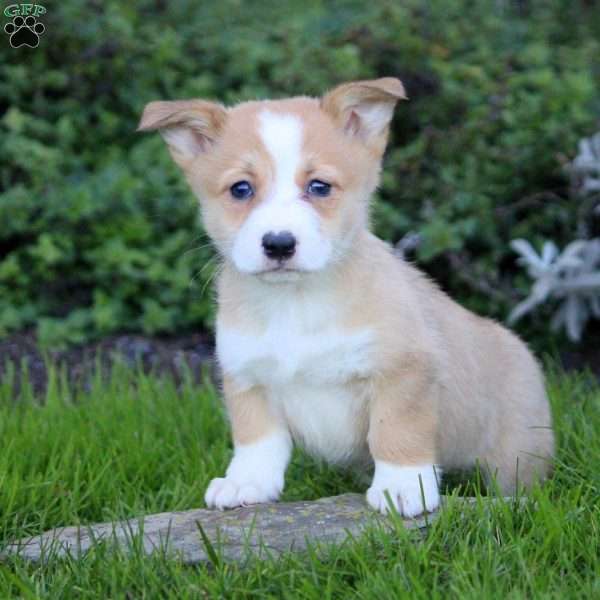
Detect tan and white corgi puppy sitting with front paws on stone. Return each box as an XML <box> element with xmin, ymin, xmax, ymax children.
<box><xmin>139</xmin><ymin>77</ymin><xmax>553</xmax><ymax>517</ymax></box>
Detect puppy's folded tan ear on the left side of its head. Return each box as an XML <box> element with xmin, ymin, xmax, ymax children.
<box><xmin>138</xmin><ymin>100</ymin><xmax>227</xmax><ymax>168</ymax></box>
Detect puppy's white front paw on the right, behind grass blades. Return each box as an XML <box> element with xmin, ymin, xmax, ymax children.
<box><xmin>367</xmin><ymin>461</ymin><xmax>440</xmax><ymax>518</ymax></box>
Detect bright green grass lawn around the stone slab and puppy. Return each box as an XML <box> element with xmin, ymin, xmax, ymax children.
<box><xmin>0</xmin><ymin>360</ymin><xmax>600</xmax><ymax>600</ymax></box>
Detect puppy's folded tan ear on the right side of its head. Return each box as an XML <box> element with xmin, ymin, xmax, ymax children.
<box><xmin>321</xmin><ymin>77</ymin><xmax>407</xmax><ymax>154</ymax></box>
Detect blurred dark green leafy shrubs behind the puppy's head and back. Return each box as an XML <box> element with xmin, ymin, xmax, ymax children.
<box><xmin>0</xmin><ymin>0</ymin><xmax>600</xmax><ymax>345</ymax></box>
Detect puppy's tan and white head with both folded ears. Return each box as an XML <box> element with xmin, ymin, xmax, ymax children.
<box><xmin>139</xmin><ymin>77</ymin><xmax>405</xmax><ymax>281</ymax></box>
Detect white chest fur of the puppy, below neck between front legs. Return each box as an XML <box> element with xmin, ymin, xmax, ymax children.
<box><xmin>217</xmin><ymin>290</ymin><xmax>374</xmax><ymax>462</ymax></box>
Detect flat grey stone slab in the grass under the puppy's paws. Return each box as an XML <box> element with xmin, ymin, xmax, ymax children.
<box><xmin>0</xmin><ymin>494</ymin><xmax>471</xmax><ymax>564</ymax></box>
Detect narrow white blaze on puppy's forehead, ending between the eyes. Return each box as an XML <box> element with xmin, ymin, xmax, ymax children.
<box><xmin>259</xmin><ymin>110</ymin><xmax>302</xmax><ymax>201</ymax></box>
